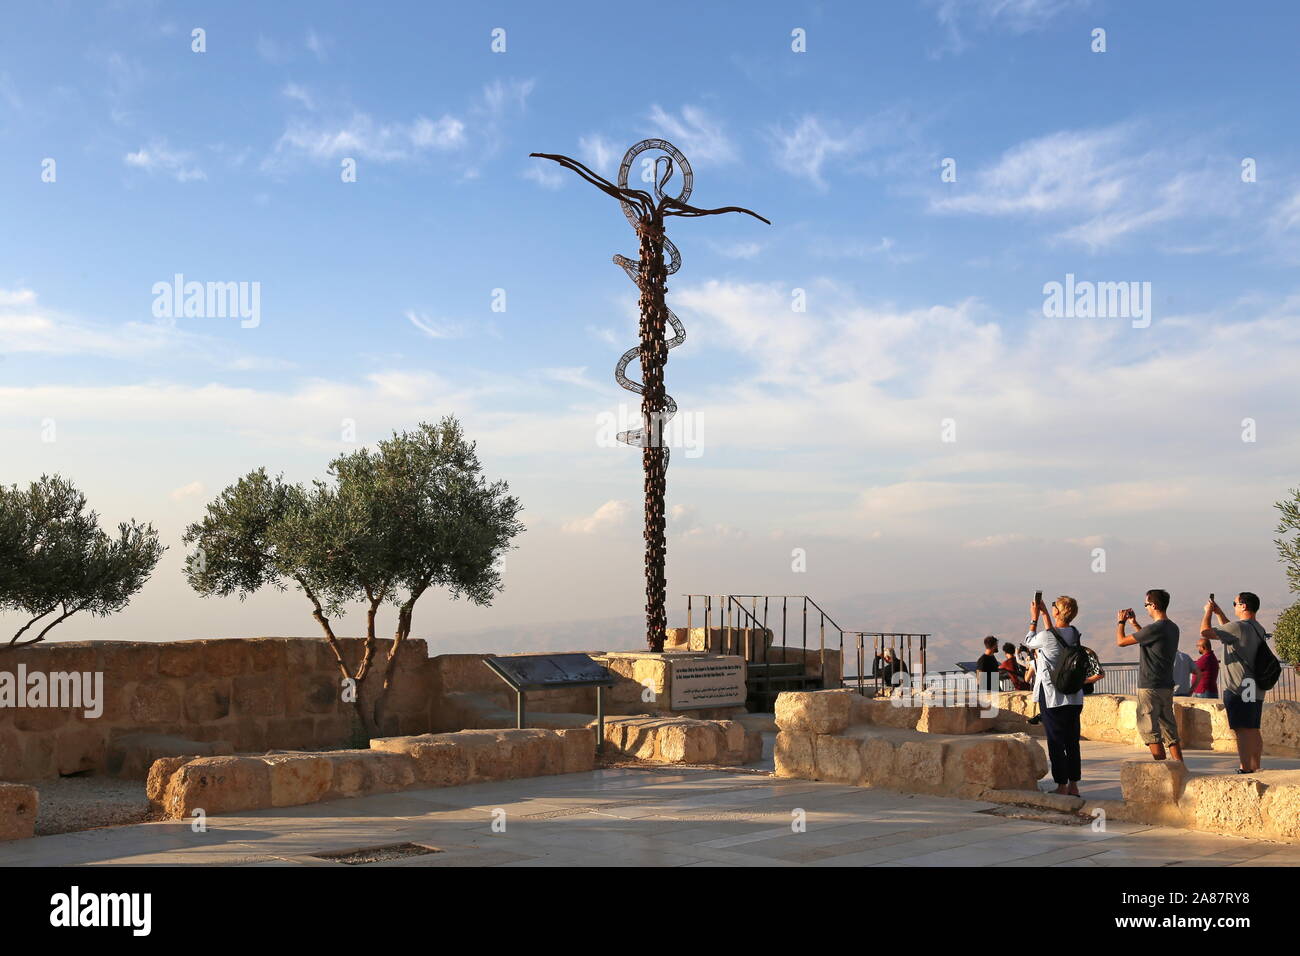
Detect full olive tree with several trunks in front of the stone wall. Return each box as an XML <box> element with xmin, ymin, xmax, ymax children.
<box><xmin>185</xmin><ymin>418</ymin><xmax>523</xmax><ymax>732</ymax></box>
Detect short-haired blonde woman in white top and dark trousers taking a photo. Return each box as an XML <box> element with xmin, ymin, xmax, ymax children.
<box><xmin>1024</xmin><ymin>594</ymin><xmax>1083</xmax><ymax>796</ymax></box>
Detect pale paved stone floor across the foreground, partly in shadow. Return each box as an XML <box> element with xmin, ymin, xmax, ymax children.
<box><xmin>0</xmin><ymin>769</ymin><xmax>1300</xmax><ymax>866</ymax></box>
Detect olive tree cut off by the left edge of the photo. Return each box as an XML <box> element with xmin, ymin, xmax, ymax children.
<box><xmin>0</xmin><ymin>475</ymin><xmax>166</xmax><ymax>650</ymax></box>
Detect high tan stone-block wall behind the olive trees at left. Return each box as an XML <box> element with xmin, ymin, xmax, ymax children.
<box><xmin>0</xmin><ymin>637</ymin><xmax>436</xmax><ymax>780</ymax></box>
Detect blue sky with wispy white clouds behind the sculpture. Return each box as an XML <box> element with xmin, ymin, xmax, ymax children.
<box><xmin>0</xmin><ymin>0</ymin><xmax>1300</xmax><ymax>671</ymax></box>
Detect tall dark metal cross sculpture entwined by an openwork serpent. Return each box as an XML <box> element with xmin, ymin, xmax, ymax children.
<box><xmin>530</xmin><ymin>139</ymin><xmax>771</xmax><ymax>652</ymax></box>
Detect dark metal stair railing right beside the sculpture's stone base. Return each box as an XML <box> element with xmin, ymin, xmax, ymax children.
<box><xmin>685</xmin><ymin>594</ymin><xmax>930</xmax><ymax>688</ymax></box>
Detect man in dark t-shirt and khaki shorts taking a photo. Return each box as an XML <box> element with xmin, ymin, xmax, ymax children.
<box><xmin>1115</xmin><ymin>588</ymin><xmax>1183</xmax><ymax>761</ymax></box>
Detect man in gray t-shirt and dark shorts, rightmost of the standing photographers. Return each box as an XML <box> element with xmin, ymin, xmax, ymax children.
<box><xmin>1201</xmin><ymin>591</ymin><xmax>1266</xmax><ymax>774</ymax></box>
